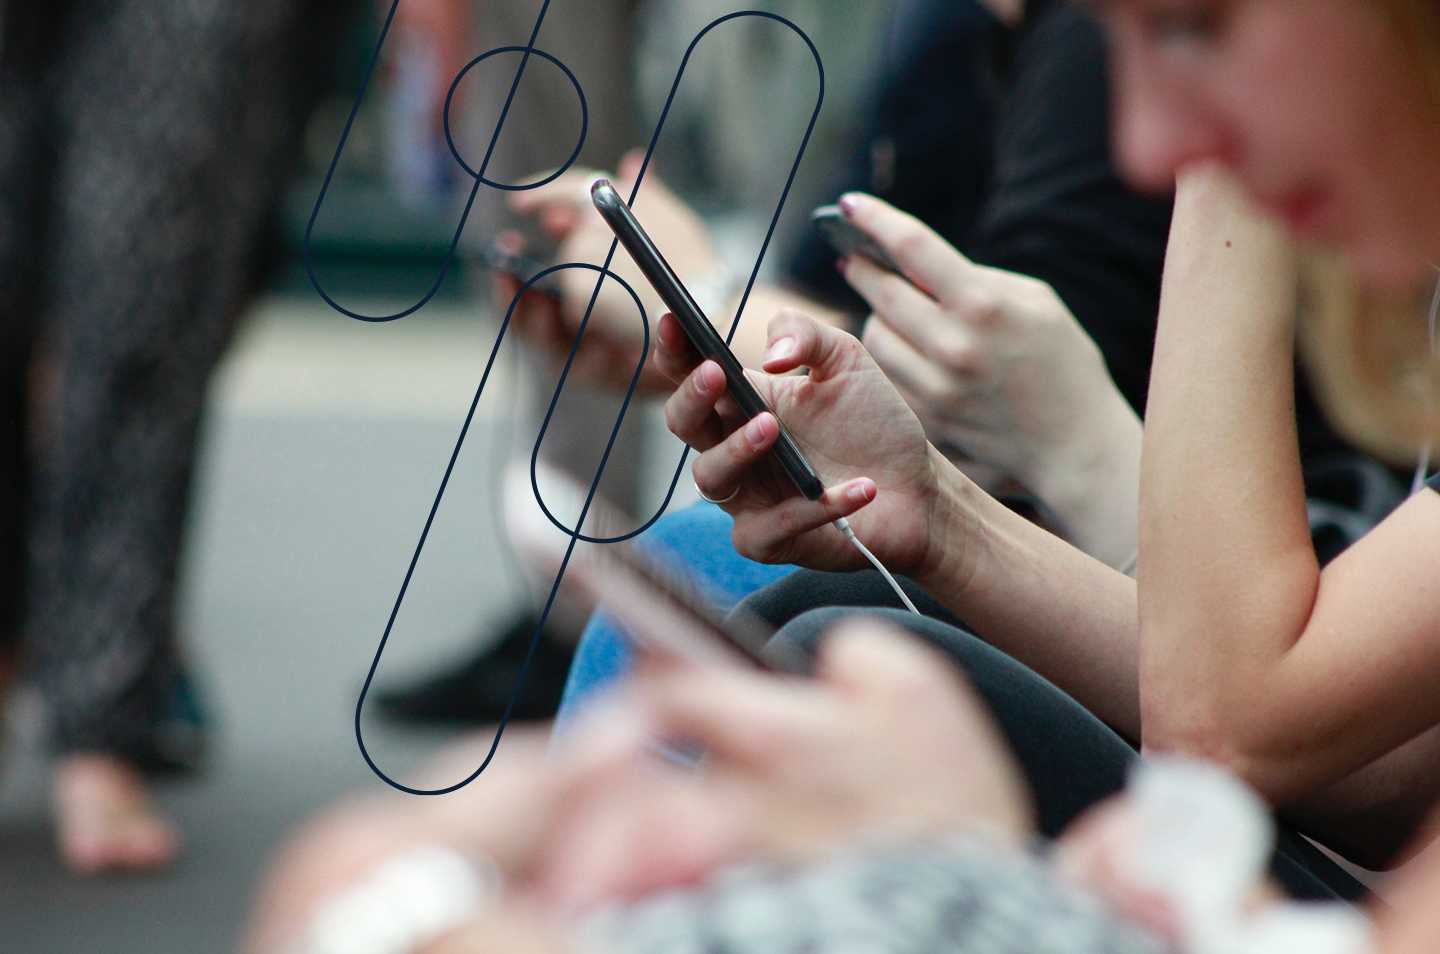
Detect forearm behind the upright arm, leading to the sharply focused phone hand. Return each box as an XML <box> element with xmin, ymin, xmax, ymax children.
<box><xmin>917</xmin><ymin>450</ymin><xmax>1140</xmax><ymax>739</ymax></box>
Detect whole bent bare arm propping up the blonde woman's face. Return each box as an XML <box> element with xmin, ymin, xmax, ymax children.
<box><xmin>1139</xmin><ymin>170</ymin><xmax>1440</xmax><ymax>804</ymax></box>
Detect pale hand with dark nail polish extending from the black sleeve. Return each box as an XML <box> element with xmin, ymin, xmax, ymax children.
<box><xmin>842</xmin><ymin>195</ymin><xmax>1123</xmax><ymax>489</ymax></box>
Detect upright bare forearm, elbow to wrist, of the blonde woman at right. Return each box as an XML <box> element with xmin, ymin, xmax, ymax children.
<box><xmin>1139</xmin><ymin>166</ymin><xmax>1319</xmax><ymax>771</ymax></box>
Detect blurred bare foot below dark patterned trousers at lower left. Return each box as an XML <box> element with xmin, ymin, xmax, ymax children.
<box><xmin>53</xmin><ymin>754</ymin><xmax>180</xmax><ymax>875</ymax></box>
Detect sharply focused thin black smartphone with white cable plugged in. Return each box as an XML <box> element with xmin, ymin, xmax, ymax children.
<box><xmin>590</xmin><ymin>179</ymin><xmax>825</xmax><ymax>500</ymax></box>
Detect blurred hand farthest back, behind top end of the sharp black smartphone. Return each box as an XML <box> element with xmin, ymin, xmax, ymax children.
<box><xmin>505</xmin><ymin>151</ymin><xmax>732</xmax><ymax>385</ymax></box>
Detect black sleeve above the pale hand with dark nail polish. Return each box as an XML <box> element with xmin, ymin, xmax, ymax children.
<box><xmin>972</xmin><ymin>3</ymin><xmax>1171</xmax><ymax>412</ymax></box>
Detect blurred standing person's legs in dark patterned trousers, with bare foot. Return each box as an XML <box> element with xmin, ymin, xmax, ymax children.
<box><xmin>0</xmin><ymin>0</ymin><xmax>346</xmax><ymax>872</ymax></box>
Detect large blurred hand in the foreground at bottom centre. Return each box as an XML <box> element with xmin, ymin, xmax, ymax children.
<box><xmin>536</xmin><ymin>623</ymin><xmax>1034</xmax><ymax>908</ymax></box>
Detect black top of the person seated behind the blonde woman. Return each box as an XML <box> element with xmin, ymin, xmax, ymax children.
<box><xmin>791</xmin><ymin>0</ymin><xmax>1408</xmax><ymax>493</ymax></box>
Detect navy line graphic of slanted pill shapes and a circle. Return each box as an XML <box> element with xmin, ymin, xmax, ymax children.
<box><xmin>305</xmin><ymin>0</ymin><xmax>825</xmax><ymax>795</ymax></box>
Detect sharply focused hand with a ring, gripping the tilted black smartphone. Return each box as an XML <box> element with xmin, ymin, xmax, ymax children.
<box><xmin>654</xmin><ymin>311</ymin><xmax>953</xmax><ymax>575</ymax></box>
